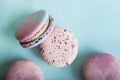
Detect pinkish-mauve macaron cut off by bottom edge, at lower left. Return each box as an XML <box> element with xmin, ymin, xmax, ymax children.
<box><xmin>6</xmin><ymin>60</ymin><xmax>44</xmax><ymax>80</ymax></box>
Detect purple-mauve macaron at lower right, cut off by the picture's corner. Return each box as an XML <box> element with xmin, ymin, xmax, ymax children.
<box><xmin>82</xmin><ymin>54</ymin><xmax>120</xmax><ymax>80</ymax></box>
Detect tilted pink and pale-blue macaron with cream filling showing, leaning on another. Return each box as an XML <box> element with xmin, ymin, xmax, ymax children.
<box><xmin>16</xmin><ymin>10</ymin><xmax>54</xmax><ymax>48</ymax></box>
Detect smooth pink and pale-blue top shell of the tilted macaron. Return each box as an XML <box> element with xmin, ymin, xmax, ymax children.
<box><xmin>16</xmin><ymin>10</ymin><xmax>49</xmax><ymax>42</ymax></box>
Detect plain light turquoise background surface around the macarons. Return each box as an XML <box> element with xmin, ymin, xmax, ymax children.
<box><xmin>0</xmin><ymin>0</ymin><xmax>120</xmax><ymax>80</ymax></box>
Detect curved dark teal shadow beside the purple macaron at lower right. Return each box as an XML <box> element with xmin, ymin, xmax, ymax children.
<box><xmin>70</xmin><ymin>47</ymin><xmax>101</xmax><ymax>80</ymax></box>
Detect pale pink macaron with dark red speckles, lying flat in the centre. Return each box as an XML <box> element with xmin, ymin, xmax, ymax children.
<box><xmin>40</xmin><ymin>28</ymin><xmax>78</xmax><ymax>67</ymax></box>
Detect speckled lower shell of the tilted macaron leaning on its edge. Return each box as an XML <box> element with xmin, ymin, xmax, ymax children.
<box><xmin>21</xmin><ymin>17</ymin><xmax>55</xmax><ymax>48</ymax></box>
